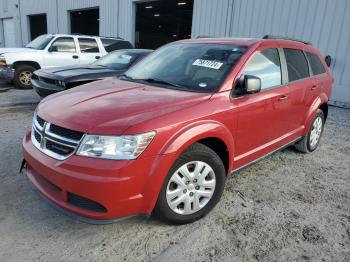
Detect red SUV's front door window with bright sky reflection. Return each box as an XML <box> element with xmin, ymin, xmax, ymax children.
<box><xmin>243</xmin><ymin>48</ymin><xmax>282</xmax><ymax>89</ymax></box>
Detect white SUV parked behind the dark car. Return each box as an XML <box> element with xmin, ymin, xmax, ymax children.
<box><xmin>0</xmin><ymin>34</ymin><xmax>133</xmax><ymax>88</ymax></box>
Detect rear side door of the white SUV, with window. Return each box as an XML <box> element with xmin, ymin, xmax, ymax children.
<box><xmin>78</xmin><ymin>37</ymin><xmax>103</xmax><ymax>64</ymax></box>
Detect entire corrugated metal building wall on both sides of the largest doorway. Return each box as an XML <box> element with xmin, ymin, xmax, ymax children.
<box><xmin>0</xmin><ymin>0</ymin><xmax>350</xmax><ymax>104</ymax></box>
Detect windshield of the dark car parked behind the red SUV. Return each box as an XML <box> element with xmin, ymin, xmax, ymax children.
<box><xmin>93</xmin><ymin>51</ymin><xmax>144</xmax><ymax>69</ymax></box>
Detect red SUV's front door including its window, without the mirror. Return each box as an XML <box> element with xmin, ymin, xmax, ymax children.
<box><xmin>232</xmin><ymin>48</ymin><xmax>290</xmax><ymax>168</ymax></box>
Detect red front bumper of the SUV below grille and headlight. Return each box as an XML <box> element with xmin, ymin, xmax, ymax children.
<box><xmin>23</xmin><ymin>132</ymin><xmax>173</xmax><ymax>223</ymax></box>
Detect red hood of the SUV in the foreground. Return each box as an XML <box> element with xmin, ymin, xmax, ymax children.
<box><xmin>37</xmin><ymin>78</ymin><xmax>211</xmax><ymax>135</ymax></box>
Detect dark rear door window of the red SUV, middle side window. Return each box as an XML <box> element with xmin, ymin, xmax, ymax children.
<box><xmin>284</xmin><ymin>48</ymin><xmax>310</xmax><ymax>82</ymax></box>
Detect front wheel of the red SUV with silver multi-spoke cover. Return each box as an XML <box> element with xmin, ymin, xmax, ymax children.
<box><xmin>155</xmin><ymin>143</ymin><xmax>226</xmax><ymax>224</ymax></box>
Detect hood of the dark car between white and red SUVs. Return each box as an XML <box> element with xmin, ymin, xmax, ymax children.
<box><xmin>36</xmin><ymin>65</ymin><xmax>122</xmax><ymax>81</ymax></box>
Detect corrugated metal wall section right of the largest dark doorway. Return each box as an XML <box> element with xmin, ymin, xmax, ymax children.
<box><xmin>192</xmin><ymin>0</ymin><xmax>350</xmax><ymax>106</ymax></box>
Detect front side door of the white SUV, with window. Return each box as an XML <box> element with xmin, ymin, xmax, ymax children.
<box><xmin>44</xmin><ymin>37</ymin><xmax>79</xmax><ymax>67</ymax></box>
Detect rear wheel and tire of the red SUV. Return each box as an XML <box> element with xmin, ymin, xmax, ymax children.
<box><xmin>294</xmin><ymin>109</ymin><xmax>325</xmax><ymax>153</ymax></box>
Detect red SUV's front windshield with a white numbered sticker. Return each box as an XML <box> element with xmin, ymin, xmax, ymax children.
<box><xmin>124</xmin><ymin>43</ymin><xmax>246</xmax><ymax>92</ymax></box>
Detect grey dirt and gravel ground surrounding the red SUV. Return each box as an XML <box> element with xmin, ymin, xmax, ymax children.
<box><xmin>0</xmin><ymin>85</ymin><xmax>350</xmax><ymax>261</ymax></box>
